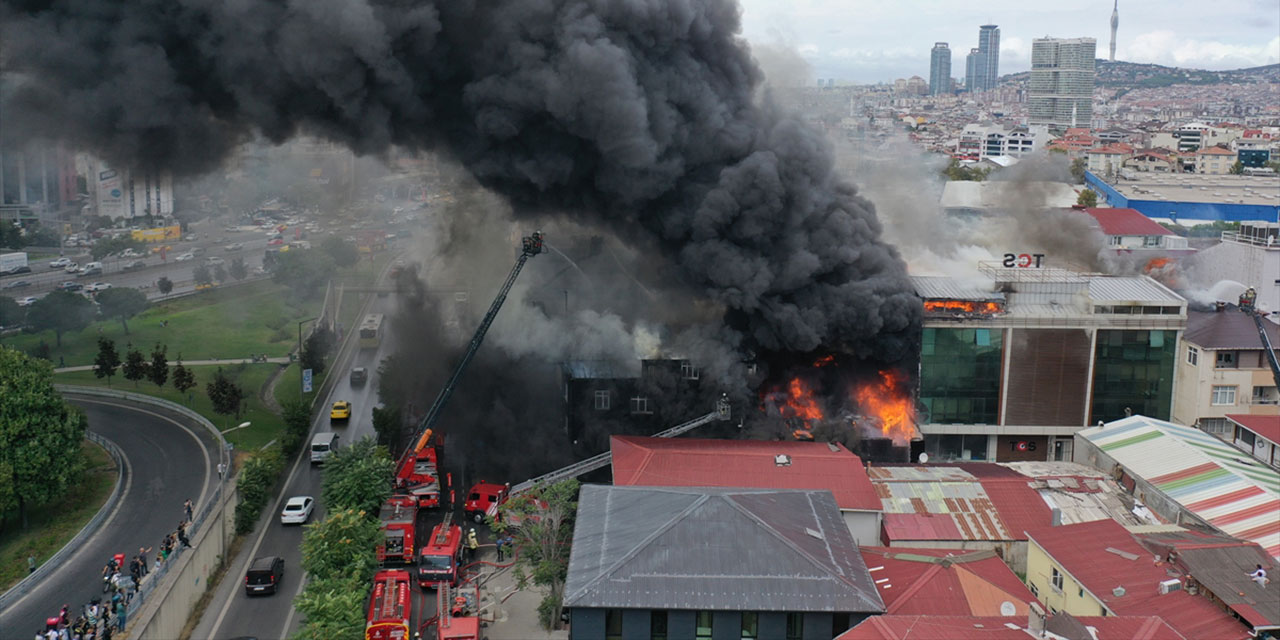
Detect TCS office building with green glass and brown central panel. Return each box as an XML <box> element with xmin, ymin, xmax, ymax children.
<box><xmin>913</xmin><ymin>262</ymin><xmax>1187</xmax><ymax>462</ymax></box>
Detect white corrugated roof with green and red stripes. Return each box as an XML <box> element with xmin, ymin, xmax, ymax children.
<box><xmin>1076</xmin><ymin>416</ymin><xmax>1280</xmax><ymax>558</ymax></box>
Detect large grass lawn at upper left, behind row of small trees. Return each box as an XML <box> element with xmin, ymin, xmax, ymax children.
<box><xmin>4</xmin><ymin>282</ymin><xmax>316</xmax><ymax>366</ymax></box>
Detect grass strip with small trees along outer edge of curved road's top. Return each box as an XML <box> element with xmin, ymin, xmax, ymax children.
<box><xmin>54</xmin><ymin>364</ymin><xmax>284</xmax><ymax>449</ymax></box>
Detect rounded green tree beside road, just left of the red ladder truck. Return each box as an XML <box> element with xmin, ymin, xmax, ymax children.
<box><xmin>320</xmin><ymin>435</ymin><xmax>396</xmax><ymax>513</ymax></box>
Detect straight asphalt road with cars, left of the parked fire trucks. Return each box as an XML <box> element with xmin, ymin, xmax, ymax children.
<box><xmin>192</xmin><ymin>297</ymin><xmax>450</xmax><ymax>640</ymax></box>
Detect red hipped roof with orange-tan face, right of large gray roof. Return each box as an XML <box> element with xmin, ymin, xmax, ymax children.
<box><xmin>860</xmin><ymin>547</ymin><xmax>1036</xmax><ymax>617</ymax></box>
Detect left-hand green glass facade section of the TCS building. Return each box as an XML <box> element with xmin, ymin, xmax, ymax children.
<box><xmin>920</xmin><ymin>328</ymin><xmax>1004</xmax><ymax>424</ymax></box>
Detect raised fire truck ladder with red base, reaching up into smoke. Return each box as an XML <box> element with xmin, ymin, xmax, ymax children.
<box><xmin>396</xmin><ymin>232</ymin><xmax>545</xmax><ymax>507</ymax></box>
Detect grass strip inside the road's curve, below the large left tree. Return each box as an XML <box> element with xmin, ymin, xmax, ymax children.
<box><xmin>0</xmin><ymin>440</ymin><xmax>116</xmax><ymax>591</ymax></box>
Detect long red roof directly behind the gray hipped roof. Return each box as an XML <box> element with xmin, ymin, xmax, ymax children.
<box><xmin>611</xmin><ymin>435</ymin><xmax>882</xmax><ymax>511</ymax></box>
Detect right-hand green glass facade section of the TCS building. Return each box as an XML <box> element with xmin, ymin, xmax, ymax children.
<box><xmin>1089</xmin><ymin>329</ymin><xmax>1178</xmax><ymax>424</ymax></box>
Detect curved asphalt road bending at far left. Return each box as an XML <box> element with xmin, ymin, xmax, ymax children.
<box><xmin>0</xmin><ymin>396</ymin><xmax>218</xmax><ymax>639</ymax></box>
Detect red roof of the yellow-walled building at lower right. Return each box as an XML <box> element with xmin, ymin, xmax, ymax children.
<box><xmin>1030</xmin><ymin>520</ymin><xmax>1252</xmax><ymax>640</ymax></box>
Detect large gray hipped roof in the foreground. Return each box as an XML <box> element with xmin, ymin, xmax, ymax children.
<box><xmin>564</xmin><ymin>485</ymin><xmax>884</xmax><ymax>613</ymax></box>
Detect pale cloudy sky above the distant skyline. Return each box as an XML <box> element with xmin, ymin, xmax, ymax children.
<box><xmin>740</xmin><ymin>0</ymin><xmax>1280</xmax><ymax>83</ymax></box>
